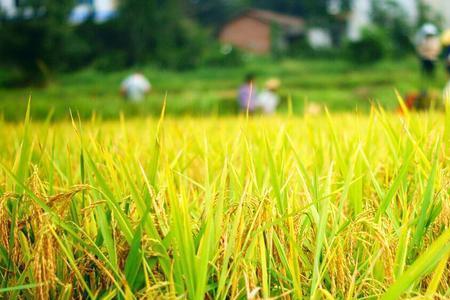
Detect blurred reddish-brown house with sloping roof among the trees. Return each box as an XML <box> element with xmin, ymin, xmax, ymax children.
<box><xmin>219</xmin><ymin>9</ymin><xmax>305</xmax><ymax>54</ymax></box>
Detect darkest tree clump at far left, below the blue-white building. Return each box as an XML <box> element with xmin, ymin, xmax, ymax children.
<box><xmin>0</xmin><ymin>0</ymin><xmax>73</xmax><ymax>84</ymax></box>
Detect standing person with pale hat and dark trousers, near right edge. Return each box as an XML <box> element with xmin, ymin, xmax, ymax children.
<box><xmin>416</xmin><ymin>23</ymin><xmax>441</xmax><ymax>78</ymax></box>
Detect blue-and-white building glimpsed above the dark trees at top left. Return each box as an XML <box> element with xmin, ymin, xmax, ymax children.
<box><xmin>0</xmin><ymin>0</ymin><xmax>117</xmax><ymax>23</ymax></box>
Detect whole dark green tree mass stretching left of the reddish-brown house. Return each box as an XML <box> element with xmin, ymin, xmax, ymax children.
<box><xmin>0</xmin><ymin>0</ymin><xmax>229</xmax><ymax>78</ymax></box>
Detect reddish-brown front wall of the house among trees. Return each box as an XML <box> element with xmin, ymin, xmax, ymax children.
<box><xmin>219</xmin><ymin>16</ymin><xmax>271</xmax><ymax>54</ymax></box>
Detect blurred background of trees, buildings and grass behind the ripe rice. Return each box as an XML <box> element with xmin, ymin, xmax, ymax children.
<box><xmin>0</xmin><ymin>0</ymin><xmax>450</xmax><ymax>121</ymax></box>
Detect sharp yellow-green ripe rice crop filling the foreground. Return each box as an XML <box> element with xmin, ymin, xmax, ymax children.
<box><xmin>0</xmin><ymin>104</ymin><xmax>450</xmax><ymax>299</ymax></box>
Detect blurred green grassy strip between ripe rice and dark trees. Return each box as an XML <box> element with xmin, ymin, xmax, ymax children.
<box><xmin>0</xmin><ymin>58</ymin><xmax>445</xmax><ymax>121</ymax></box>
